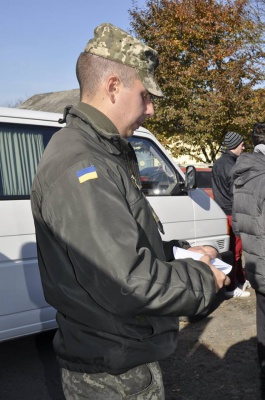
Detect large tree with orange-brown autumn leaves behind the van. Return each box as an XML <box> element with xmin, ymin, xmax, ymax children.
<box><xmin>129</xmin><ymin>0</ymin><xmax>265</xmax><ymax>163</ymax></box>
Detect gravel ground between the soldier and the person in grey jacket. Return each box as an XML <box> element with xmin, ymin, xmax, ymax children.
<box><xmin>160</xmin><ymin>289</ymin><xmax>259</xmax><ymax>400</ymax></box>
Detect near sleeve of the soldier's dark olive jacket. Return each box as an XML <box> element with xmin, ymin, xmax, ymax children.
<box><xmin>44</xmin><ymin>161</ymin><xmax>215</xmax><ymax>316</ymax></box>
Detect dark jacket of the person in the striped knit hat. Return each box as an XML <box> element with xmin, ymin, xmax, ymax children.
<box><xmin>212</xmin><ymin>150</ymin><xmax>238</xmax><ymax>215</ymax></box>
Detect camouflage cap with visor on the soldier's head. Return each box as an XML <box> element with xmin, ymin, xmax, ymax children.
<box><xmin>84</xmin><ymin>23</ymin><xmax>164</xmax><ymax>97</ymax></box>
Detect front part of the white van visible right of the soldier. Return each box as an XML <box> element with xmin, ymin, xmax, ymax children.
<box><xmin>130</xmin><ymin>133</ymin><xmax>229</xmax><ymax>253</ymax></box>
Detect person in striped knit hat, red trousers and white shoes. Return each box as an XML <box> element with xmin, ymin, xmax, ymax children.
<box><xmin>212</xmin><ymin>132</ymin><xmax>250</xmax><ymax>298</ymax></box>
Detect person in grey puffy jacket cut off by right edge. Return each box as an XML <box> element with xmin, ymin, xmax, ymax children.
<box><xmin>233</xmin><ymin>122</ymin><xmax>265</xmax><ymax>400</ymax></box>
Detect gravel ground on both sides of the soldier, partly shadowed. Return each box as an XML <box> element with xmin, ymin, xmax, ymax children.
<box><xmin>0</xmin><ymin>289</ymin><xmax>259</xmax><ymax>400</ymax></box>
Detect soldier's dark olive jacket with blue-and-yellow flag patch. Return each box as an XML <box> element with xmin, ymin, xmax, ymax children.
<box><xmin>31</xmin><ymin>103</ymin><xmax>215</xmax><ymax>374</ymax></box>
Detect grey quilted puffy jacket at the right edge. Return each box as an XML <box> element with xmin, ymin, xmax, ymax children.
<box><xmin>233</xmin><ymin>145</ymin><xmax>265</xmax><ymax>294</ymax></box>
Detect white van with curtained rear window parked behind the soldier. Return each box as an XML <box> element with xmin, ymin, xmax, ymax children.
<box><xmin>0</xmin><ymin>107</ymin><xmax>229</xmax><ymax>341</ymax></box>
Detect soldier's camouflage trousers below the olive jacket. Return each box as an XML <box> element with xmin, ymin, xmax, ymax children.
<box><xmin>61</xmin><ymin>362</ymin><xmax>165</xmax><ymax>400</ymax></box>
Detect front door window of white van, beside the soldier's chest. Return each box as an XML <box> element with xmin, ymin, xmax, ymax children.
<box><xmin>129</xmin><ymin>136</ymin><xmax>179</xmax><ymax>196</ymax></box>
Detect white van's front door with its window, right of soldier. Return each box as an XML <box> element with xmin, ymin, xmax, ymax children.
<box><xmin>129</xmin><ymin>134</ymin><xmax>195</xmax><ymax>240</ymax></box>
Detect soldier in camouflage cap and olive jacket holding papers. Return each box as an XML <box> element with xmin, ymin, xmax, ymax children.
<box><xmin>31</xmin><ymin>23</ymin><xmax>230</xmax><ymax>400</ymax></box>
